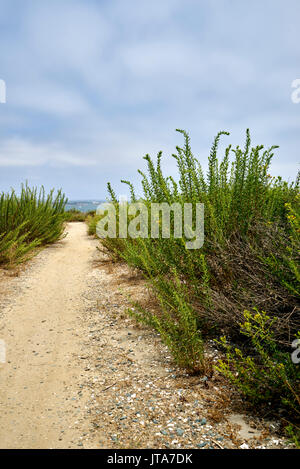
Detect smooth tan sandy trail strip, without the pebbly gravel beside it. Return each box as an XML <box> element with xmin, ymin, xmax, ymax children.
<box><xmin>0</xmin><ymin>223</ymin><xmax>96</xmax><ymax>448</ymax></box>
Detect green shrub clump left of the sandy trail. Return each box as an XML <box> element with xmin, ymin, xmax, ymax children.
<box><xmin>0</xmin><ymin>185</ymin><xmax>67</xmax><ymax>266</ymax></box>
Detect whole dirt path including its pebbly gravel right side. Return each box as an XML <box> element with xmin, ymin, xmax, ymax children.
<box><xmin>0</xmin><ymin>223</ymin><xmax>287</xmax><ymax>449</ymax></box>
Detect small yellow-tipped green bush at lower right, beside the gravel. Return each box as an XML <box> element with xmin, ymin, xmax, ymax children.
<box><xmin>216</xmin><ymin>310</ymin><xmax>300</xmax><ymax>444</ymax></box>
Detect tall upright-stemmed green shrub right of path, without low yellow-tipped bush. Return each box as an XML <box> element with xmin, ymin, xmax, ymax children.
<box><xmin>89</xmin><ymin>129</ymin><xmax>299</xmax><ymax>369</ymax></box>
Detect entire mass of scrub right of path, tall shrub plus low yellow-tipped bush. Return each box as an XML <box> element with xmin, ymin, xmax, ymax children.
<box><xmin>89</xmin><ymin>130</ymin><xmax>300</xmax><ymax>441</ymax></box>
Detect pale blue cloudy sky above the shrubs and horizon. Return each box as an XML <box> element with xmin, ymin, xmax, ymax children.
<box><xmin>0</xmin><ymin>0</ymin><xmax>300</xmax><ymax>199</ymax></box>
